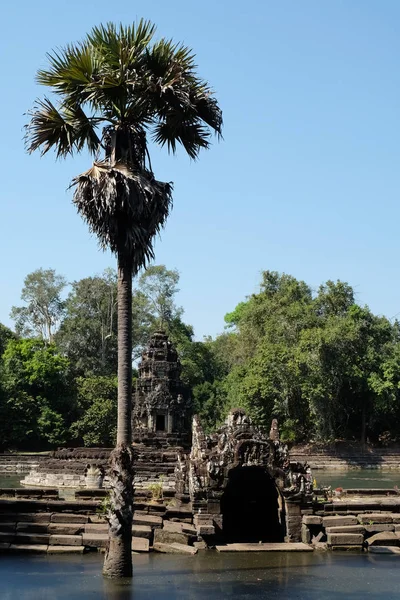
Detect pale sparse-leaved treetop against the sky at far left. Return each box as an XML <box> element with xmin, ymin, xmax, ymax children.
<box><xmin>10</xmin><ymin>269</ymin><xmax>67</xmax><ymax>343</ymax></box>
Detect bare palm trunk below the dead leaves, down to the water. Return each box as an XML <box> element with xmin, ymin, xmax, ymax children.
<box><xmin>103</xmin><ymin>256</ymin><xmax>133</xmax><ymax>577</ymax></box>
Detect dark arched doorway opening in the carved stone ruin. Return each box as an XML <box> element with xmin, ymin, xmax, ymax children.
<box><xmin>221</xmin><ymin>467</ymin><xmax>284</xmax><ymax>543</ymax></box>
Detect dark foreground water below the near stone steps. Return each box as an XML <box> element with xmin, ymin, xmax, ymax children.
<box><xmin>0</xmin><ymin>551</ymin><xmax>400</xmax><ymax>600</ymax></box>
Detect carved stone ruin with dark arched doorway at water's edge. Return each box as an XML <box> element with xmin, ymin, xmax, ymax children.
<box><xmin>176</xmin><ymin>408</ymin><xmax>312</xmax><ymax>542</ymax></box>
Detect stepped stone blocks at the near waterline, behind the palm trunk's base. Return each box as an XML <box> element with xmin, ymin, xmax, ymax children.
<box><xmin>0</xmin><ymin>490</ymin><xmax>197</xmax><ymax>554</ymax></box>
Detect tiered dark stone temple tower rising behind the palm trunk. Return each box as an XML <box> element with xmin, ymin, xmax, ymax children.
<box><xmin>132</xmin><ymin>331</ymin><xmax>192</xmax><ymax>447</ymax></box>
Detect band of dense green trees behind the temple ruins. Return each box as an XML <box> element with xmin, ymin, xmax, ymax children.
<box><xmin>0</xmin><ymin>265</ymin><xmax>400</xmax><ymax>448</ymax></box>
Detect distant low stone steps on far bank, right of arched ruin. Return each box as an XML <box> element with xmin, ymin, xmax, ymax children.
<box><xmin>289</xmin><ymin>445</ymin><xmax>400</xmax><ymax>471</ymax></box>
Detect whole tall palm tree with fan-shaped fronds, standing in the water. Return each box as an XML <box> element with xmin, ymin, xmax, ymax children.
<box><xmin>26</xmin><ymin>20</ymin><xmax>222</xmax><ymax>577</ymax></box>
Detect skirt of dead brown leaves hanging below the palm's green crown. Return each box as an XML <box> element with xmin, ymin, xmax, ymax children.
<box><xmin>72</xmin><ymin>162</ymin><xmax>172</xmax><ymax>273</ymax></box>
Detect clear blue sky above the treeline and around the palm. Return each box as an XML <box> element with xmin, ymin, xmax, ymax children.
<box><xmin>0</xmin><ymin>0</ymin><xmax>400</xmax><ymax>337</ymax></box>
